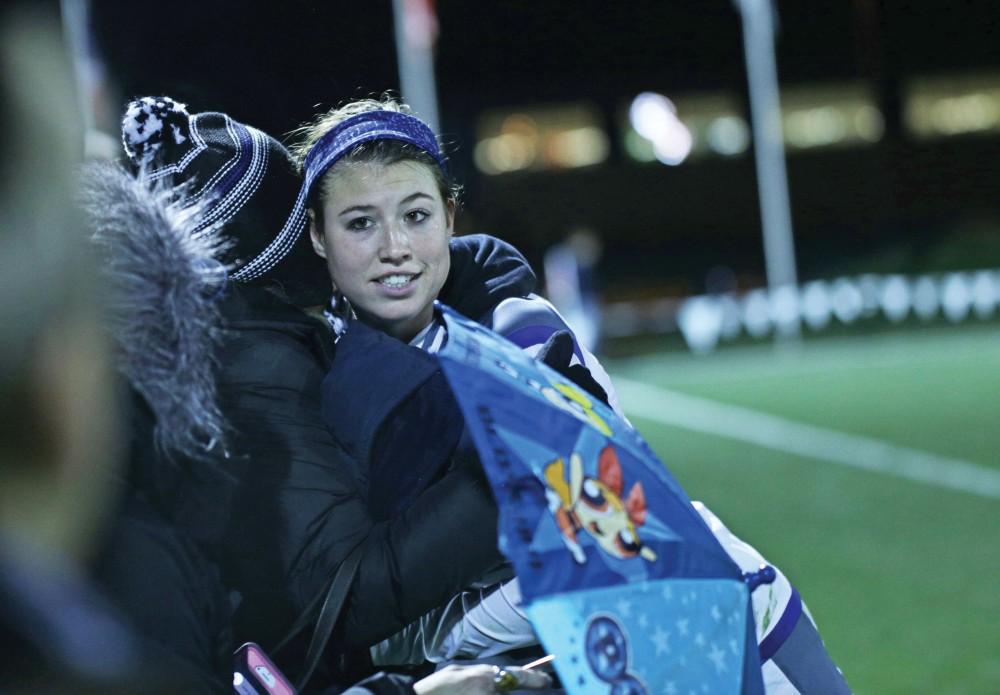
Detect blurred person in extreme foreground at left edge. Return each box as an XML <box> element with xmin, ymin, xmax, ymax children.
<box><xmin>0</xmin><ymin>3</ymin><xmax>171</xmax><ymax>693</ymax></box>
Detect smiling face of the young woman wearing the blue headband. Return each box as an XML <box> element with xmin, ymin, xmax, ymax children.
<box><xmin>311</xmin><ymin>161</ymin><xmax>454</xmax><ymax>341</ymax></box>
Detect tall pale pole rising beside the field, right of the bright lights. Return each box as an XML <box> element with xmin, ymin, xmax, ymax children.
<box><xmin>734</xmin><ymin>0</ymin><xmax>799</xmax><ymax>336</ymax></box>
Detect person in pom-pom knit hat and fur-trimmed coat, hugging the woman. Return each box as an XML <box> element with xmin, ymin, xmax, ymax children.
<box><xmin>88</xmin><ymin>97</ymin><xmax>560</xmax><ymax>685</ymax></box>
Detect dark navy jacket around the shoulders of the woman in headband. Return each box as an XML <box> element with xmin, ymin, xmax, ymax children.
<box><xmin>322</xmin><ymin>234</ymin><xmax>535</xmax><ymax>519</ymax></box>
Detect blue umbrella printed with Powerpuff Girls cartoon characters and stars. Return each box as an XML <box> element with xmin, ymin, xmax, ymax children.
<box><xmin>438</xmin><ymin>307</ymin><xmax>763</xmax><ymax>695</ymax></box>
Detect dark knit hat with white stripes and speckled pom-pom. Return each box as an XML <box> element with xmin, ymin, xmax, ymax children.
<box><xmin>122</xmin><ymin>97</ymin><xmax>329</xmax><ymax>306</ymax></box>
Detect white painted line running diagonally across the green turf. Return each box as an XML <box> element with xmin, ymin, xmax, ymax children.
<box><xmin>614</xmin><ymin>377</ymin><xmax>1000</xmax><ymax>499</ymax></box>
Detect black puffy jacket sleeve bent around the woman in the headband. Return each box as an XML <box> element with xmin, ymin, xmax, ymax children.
<box><xmin>216</xmin><ymin>324</ymin><xmax>501</xmax><ymax>646</ymax></box>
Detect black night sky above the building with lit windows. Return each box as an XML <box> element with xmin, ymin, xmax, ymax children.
<box><xmin>95</xmin><ymin>0</ymin><xmax>1000</xmax><ymax>130</ymax></box>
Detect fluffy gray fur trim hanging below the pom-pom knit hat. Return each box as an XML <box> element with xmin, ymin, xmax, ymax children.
<box><xmin>83</xmin><ymin>163</ymin><xmax>228</xmax><ymax>458</ymax></box>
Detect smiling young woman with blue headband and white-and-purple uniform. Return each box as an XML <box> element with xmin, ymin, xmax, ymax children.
<box><xmin>297</xmin><ymin>95</ymin><xmax>846</xmax><ymax>692</ymax></box>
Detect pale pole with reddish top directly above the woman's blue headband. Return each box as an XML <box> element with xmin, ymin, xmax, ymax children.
<box><xmin>392</xmin><ymin>0</ymin><xmax>441</xmax><ymax>133</ymax></box>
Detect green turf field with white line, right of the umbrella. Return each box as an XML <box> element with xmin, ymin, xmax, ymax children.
<box><xmin>605</xmin><ymin>322</ymin><xmax>1000</xmax><ymax>695</ymax></box>
